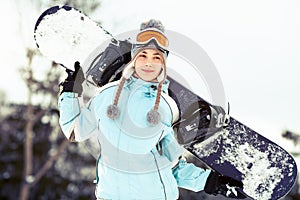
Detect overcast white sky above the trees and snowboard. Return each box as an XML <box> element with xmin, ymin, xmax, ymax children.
<box><xmin>0</xmin><ymin>0</ymin><xmax>300</xmax><ymax>151</ymax></box>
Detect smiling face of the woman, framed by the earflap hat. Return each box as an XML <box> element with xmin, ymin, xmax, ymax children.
<box><xmin>135</xmin><ymin>49</ymin><xmax>164</xmax><ymax>82</ymax></box>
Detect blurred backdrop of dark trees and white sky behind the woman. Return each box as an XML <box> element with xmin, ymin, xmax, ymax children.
<box><xmin>0</xmin><ymin>0</ymin><xmax>300</xmax><ymax>200</ymax></box>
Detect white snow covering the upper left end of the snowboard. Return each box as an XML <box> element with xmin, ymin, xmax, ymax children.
<box><xmin>35</xmin><ymin>5</ymin><xmax>110</xmax><ymax>69</ymax></box>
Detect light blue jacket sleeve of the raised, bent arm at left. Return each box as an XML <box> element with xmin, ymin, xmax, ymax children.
<box><xmin>58</xmin><ymin>92</ymin><xmax>97</xmax><ymax>142</ymax></box>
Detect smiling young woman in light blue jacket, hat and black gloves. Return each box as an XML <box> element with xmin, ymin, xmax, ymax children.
<box><xmin>59</xmin><ymin>20</ymin><xmax>244</xmax><ymax>200</ymax></box>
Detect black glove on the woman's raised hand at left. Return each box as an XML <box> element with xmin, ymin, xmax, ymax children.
<box><xmin>59</xmin><ymin>61</ymin><xmax>85</xmax><ymax>96</ymax></box>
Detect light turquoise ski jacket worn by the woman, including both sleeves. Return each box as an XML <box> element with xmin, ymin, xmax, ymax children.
<box><xmin>58</xmin><ymin>77</ymin><xmax>210</xmax><ymax>200</ymax></box>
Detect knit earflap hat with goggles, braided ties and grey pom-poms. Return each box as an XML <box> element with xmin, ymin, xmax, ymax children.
<box><xmin>107</xmin><ymin>19</ymin><xmax>169</xmax><ymax>125</ymax></box>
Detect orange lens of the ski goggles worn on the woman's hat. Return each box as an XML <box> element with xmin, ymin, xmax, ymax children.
<box><xmin>136</xmin><ymin>30</ymin><xmax>169</xmax><ymax>48</ymax></box>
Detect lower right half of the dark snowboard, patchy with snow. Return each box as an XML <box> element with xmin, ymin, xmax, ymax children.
<box><xmin>169</xmin><ymin>78</ymin><xmax>297</xmax><ymax>199</ymax></box>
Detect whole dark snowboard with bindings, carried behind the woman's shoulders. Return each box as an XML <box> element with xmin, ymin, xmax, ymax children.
<box><xmin>34</xmin><ymin>6</ymin><xmax>297</xmax><ymax>199</ymax></box>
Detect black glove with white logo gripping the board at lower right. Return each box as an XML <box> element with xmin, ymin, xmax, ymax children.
<box><xmin>204</xmin><ymin>171</ymin><xmax>247</xmax><ymax>199</ymax></box>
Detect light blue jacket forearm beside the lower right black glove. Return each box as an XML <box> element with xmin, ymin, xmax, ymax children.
<box><xmin>173</xmin><ymin>159</ymin><xmax>211</xmax><ymax>192</ymax></box>
